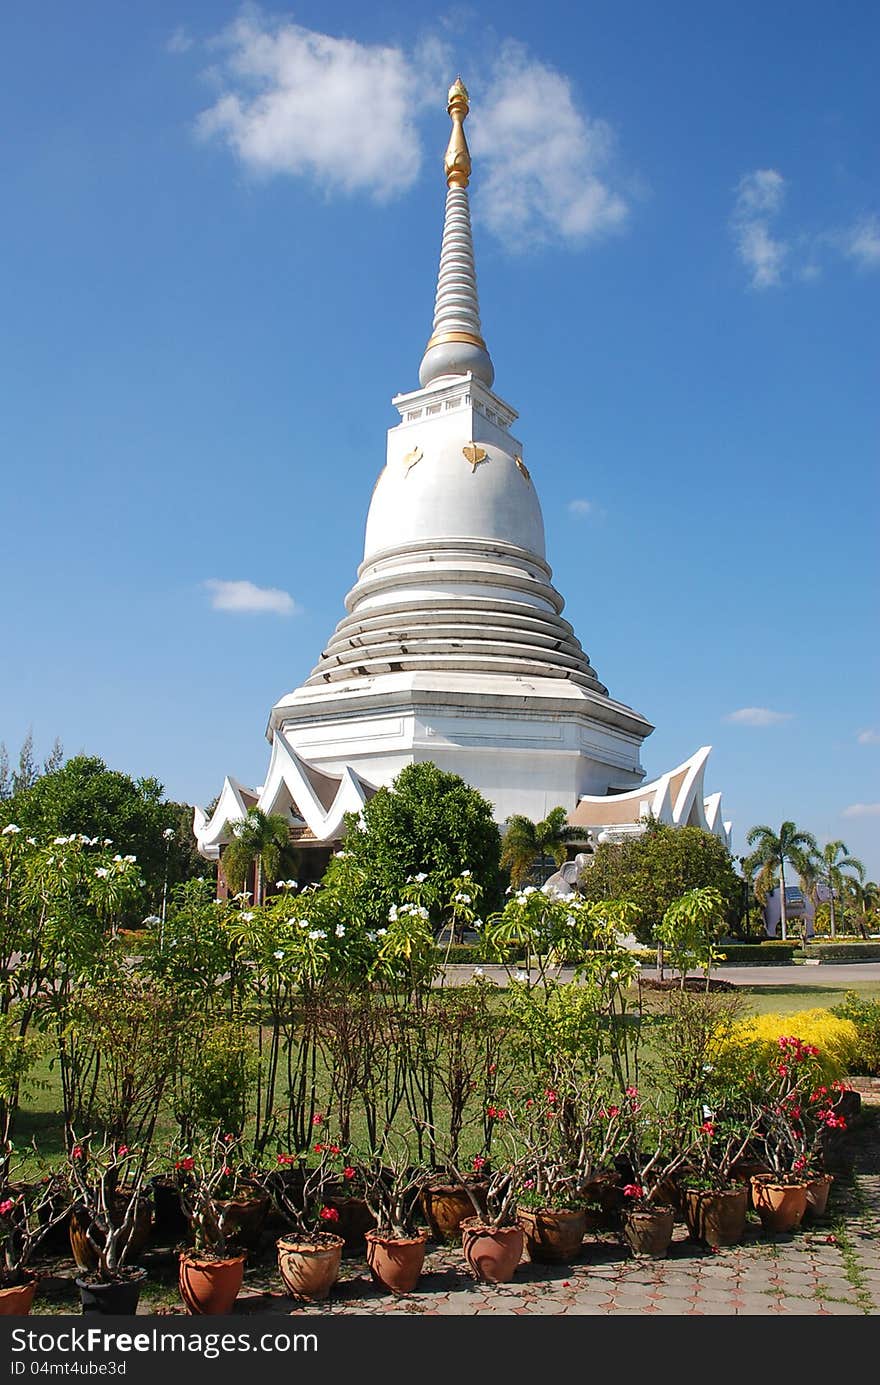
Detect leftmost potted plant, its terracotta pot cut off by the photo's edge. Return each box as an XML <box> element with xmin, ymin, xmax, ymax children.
<box><xmin>0</xmin><ymin>1145</ymin><xmax>69</xmax><ymax>1317</ymax></box>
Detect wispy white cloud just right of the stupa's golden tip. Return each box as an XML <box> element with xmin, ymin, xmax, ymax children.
<box><xmin>471</xmin><ymin>40</ymin><xmax>628</xmax><ymax>251</ymax></box>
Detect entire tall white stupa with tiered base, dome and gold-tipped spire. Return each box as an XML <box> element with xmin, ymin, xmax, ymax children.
<box><xmin>194</xmin><ymin>79</ymin><xmax>731</xmax><ymax>859</ymax></box>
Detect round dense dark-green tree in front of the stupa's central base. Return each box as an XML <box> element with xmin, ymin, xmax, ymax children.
<box><xmin>324</xmin><ymin>760</ymin><xmax>502</xmax><ymax>929</ymax></box>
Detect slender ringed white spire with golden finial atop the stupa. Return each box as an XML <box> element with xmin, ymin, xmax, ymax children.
<box><xmin>419</xmin><ymin>78</ymin><xmax>495</xmax><ymax>389</ymax></box>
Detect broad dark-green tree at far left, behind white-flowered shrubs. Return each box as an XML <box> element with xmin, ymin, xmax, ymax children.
<box><xmin>0</xmin><ymin>752</ymin><xmax>206</xmax><ymax>922</ymax></box>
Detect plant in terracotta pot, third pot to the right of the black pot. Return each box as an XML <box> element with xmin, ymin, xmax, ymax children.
<box><xmin>356</xmin><ymin>1134</ymin><xmax>428</xmax><ymax>1294</ymax></box>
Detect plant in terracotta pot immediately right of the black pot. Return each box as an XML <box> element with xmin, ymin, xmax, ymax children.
<box><xmin>175</xmin><ymin>1130</ymin><xmax>245</xmax><ymax>1314</ymax></box>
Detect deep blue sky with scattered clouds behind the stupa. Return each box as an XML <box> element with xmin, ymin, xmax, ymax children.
<box><xmin>0</xmin><ymin>0</ymin><xmax>880</xmax><ymax>878</ymax></box>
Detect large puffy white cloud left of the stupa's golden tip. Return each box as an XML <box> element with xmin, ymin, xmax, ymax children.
<box><xmin>197</xmin><ymin>11</ymin><xmax>424</xmax><ymax>201</ymax></box>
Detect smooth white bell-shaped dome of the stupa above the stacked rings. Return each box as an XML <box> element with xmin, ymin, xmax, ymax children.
<box><xmin>363</xmin><ymin>436</ymin><xmax>545</xmax><ymax>562</ymax></box>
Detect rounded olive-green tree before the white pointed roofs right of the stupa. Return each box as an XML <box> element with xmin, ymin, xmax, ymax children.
<box><xmin>579</xmin><ymin>821</ymin><xmax>743</xmax><ymax>945</ymax></box>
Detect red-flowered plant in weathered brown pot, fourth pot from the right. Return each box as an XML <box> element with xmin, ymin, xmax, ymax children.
<box><xmin>621</xmin><ymin>1087</ymin><xmax>692</xmax><ymax>1260</ymax></box>
